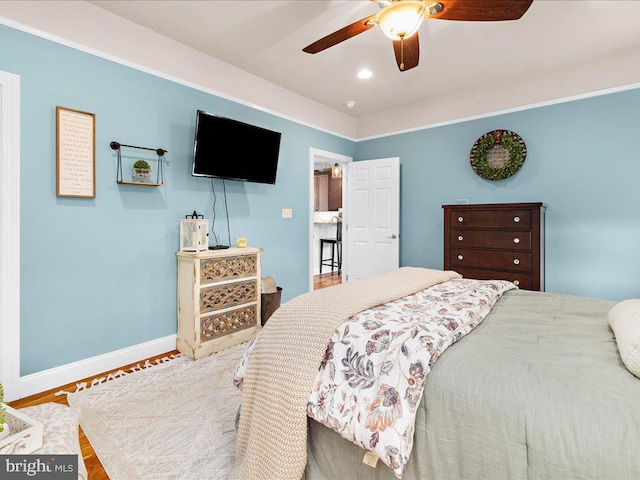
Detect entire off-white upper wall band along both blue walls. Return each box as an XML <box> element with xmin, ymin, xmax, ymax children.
<box><xmin>0</xmin><ymin>1</ymin><xmax>640</xmax><ymax>140</ymax></box>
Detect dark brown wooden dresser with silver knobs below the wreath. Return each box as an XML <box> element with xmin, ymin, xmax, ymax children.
<box><xmin>442</xmin><ymin>203</ymin><xmax>545</xmax><ymax>291</ymax></box>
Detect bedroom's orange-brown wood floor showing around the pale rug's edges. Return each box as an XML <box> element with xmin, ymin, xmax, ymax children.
<box><xmin>9</xmin><ymin>350</ymin><xmax>178</xmax><ymax>480</ymax></box>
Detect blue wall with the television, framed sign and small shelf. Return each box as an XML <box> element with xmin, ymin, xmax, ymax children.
<box><xmin>0</xmin><ymin>27</ymin><xmax>355</xmax><ymax>375</ymax></box>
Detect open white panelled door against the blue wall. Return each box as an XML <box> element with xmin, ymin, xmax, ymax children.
<box><xmin>346</xmin><ymin>157</ymin><xmax>400</xmax><ymax>282</ymax></box>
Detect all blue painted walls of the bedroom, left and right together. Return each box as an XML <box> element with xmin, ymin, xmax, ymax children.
<box><xmin>0</xmin><ymin>21</ymin><xmax>640</xmax><ymax>375</ymax></box>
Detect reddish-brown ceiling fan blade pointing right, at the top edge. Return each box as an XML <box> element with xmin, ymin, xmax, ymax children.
<box><xmin>429</xmin><ymin>0</ymin><xmax>533</xmax><ymax>22</ymax></box>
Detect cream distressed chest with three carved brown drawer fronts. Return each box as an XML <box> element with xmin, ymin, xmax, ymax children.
<box><xmin>176</xmin><ymin>248</ymin><xmax>262</xmax><ymax>359</ymax></box>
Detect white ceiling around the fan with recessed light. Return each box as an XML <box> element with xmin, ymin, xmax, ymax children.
<box><xmin>90</xmin><ymin>0</ymin><xmax>640</xmax><ymax>122</ymax></box>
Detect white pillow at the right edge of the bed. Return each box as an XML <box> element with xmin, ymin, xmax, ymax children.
<box><xmin>609</xmin><ymin>298</ymin><xmax>640</xmax><ymax>378</ymax></box>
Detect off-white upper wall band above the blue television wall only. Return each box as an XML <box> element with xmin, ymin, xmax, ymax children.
<box><xmin>0</xmin><ymin>1</ymin><xmax>356</xmax><ymax>140</ymax></box>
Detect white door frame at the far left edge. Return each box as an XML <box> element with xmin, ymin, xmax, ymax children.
<box><xmin>0</xmin><ymin>71</ymin><xmax>20</xmax><ymax>401</ymax></box>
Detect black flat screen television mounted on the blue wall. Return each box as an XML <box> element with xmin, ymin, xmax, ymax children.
<box><xmin>192</xmin><ymin>110</ymin><xmax>281</xmax><ymax>185</ymax></box>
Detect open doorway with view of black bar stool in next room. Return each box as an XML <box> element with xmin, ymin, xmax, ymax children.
<box><xmin>309</xmin><ymin>148</ymin><xmax>353</xmax><ymax>291</ymax></box>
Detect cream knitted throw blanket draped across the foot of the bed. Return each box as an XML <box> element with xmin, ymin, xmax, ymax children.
<box><xmin>231</xmin><ymin>267</ymin><xmax>460</xmax><ymax>480</ymax></box>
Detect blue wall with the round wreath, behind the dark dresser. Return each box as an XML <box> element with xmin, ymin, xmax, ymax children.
<box><xmin>356</xmin><ymin>90</ymin><xmax>640</xmax><ymax>300</ymax></box>
